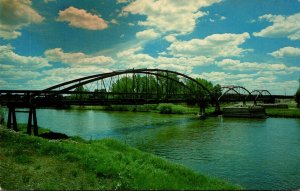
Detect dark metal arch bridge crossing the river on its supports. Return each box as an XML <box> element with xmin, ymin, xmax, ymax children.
<box><xmin>0</xmin><ymin>69</ymin><xmax>292</xmax><ymax>135</ymax></box>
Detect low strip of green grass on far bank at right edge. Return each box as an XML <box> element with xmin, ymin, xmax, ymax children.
<box><xmin>266</xmin><ymin>108</ymin><xmax>300</xmax><ymax>118</ymax></box>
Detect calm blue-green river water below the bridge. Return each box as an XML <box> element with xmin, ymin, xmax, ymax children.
<box><xmin>12</xmin><ymin>109</ymin><xmax>300</xmax><ymax>189</ymax></box>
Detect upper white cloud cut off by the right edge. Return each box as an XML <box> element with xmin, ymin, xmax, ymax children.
<box><xmin>253</xmin><ymin>13</ymin><xmax>300</xmax><ymax>40</ymax></box>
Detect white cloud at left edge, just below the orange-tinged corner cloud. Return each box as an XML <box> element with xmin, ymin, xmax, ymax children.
<box><xmin>0</xmin><ymin>45</ymin><xmax>51</xmax><ymax>69</ymax></box>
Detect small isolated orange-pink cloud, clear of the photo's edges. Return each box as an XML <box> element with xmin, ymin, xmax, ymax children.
<box><xmin>57</xmin><ymin>6</ymin><xmax>108</xmax><ymax>30</ymax></box>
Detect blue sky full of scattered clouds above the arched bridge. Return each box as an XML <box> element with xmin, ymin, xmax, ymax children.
<box><xmin>0</xmin><ymin>0</ymin><xmax>300</xmax><ymax>95</ymax></box>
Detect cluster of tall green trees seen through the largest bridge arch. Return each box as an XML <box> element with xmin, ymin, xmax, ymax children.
<box><xmin>111</xmin><ymin>73</ymin><xmax>222</xmax><ymax>106</ymax></box>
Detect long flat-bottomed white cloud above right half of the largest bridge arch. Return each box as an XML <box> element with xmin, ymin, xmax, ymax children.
<box><xmin>167</xmin><ymin>32</ymin><xmax>250</xmax><ymax>58</ymax></box>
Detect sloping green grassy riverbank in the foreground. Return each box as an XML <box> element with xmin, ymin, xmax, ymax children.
<box><xmin>0</xmin><ymin>128</ymin><xmax>240</xmax><ymax>190</ymax></box>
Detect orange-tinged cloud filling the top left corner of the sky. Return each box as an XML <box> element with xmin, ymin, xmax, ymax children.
<box><xmin>0</xmin><ymin>0</ymin><xmax>44</xmax><ymax>39</ymax></box>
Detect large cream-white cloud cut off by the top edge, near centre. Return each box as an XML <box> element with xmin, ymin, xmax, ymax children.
<box><xmin>122</xmin><ymin>0</ymin><xmax>220</xmax><ymax>34</ymax></box>
